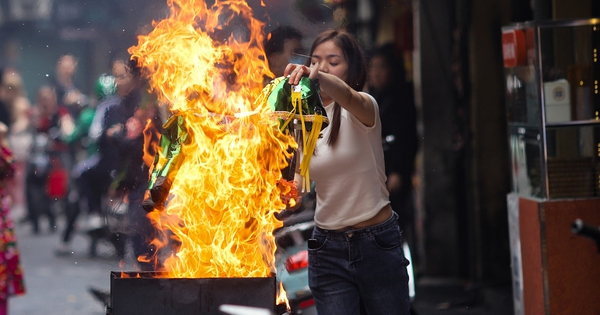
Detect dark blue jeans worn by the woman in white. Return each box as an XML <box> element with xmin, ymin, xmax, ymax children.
<box><xmin>308</xmin><ymin>212</ymin><xmax>410</xmax><ymax>315</ymax></box>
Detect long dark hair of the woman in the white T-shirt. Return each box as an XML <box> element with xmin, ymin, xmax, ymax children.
<box><xmin>310</xmin><ymin>30</ymin><xmax>367</xmax><ymax>145</ymax></box>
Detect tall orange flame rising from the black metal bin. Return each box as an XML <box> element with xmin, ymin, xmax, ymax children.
<box><xmin>129</xmin><ymin>0</ymin><xmax>296</xmax><ymax>278</ymax></box>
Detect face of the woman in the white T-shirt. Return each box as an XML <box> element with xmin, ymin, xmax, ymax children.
<box><xmin>310</xmin><ymin>40</ymin><xmax>348</xmax><ymax>104</ymax></box>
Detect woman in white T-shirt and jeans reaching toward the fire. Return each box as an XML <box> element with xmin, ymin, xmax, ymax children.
<box><xmin>284</xmin><ymin>31</ymin><xmax>409</xmax><ymax>315</ymax></box>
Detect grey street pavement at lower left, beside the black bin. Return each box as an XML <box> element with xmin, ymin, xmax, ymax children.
<box><xmin>8</xmin><ymin>207</ymin><xmax>121</xmax><ymax>315</ymax></box>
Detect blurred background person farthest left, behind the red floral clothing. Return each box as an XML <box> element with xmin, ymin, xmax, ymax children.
<box><xmin>0</xmin><ymin>68</ymin><xmax>32</xmax><ymax>222</ymax></box>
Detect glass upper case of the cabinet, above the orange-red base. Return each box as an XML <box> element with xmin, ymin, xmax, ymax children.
<box><xmin>502</xmin><ymin>19</ymin><xmax>600</xmax><ymax>199</ymax></box>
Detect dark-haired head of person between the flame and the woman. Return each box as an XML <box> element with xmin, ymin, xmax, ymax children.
<box><xmin>265</xmin><ymin>26</ymin><xmax>308</xmax><ymax>80</ymax></box>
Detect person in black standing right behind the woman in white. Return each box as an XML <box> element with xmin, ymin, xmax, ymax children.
<box><xmin>367</xmin><ymin>43</ymin><xmax>419</xmax><ymax>264</ymax></box>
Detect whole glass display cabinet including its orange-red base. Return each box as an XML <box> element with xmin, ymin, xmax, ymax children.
<box><xmin>502</xmin><ymin>18</ymin><xmax>600</xmax><ymax>315</ymax></box>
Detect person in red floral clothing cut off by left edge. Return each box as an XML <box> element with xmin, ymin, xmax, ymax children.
<box><xmin>0</xmin><ymin>123</ymin><xmax>25</xmax><ymax>315</ymax></box>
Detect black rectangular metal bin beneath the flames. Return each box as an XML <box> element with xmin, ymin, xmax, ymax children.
<box><xmin>106</xmin><ymin>271</ymin><xmax>276</xmax><ymax>315</ymax></box>
